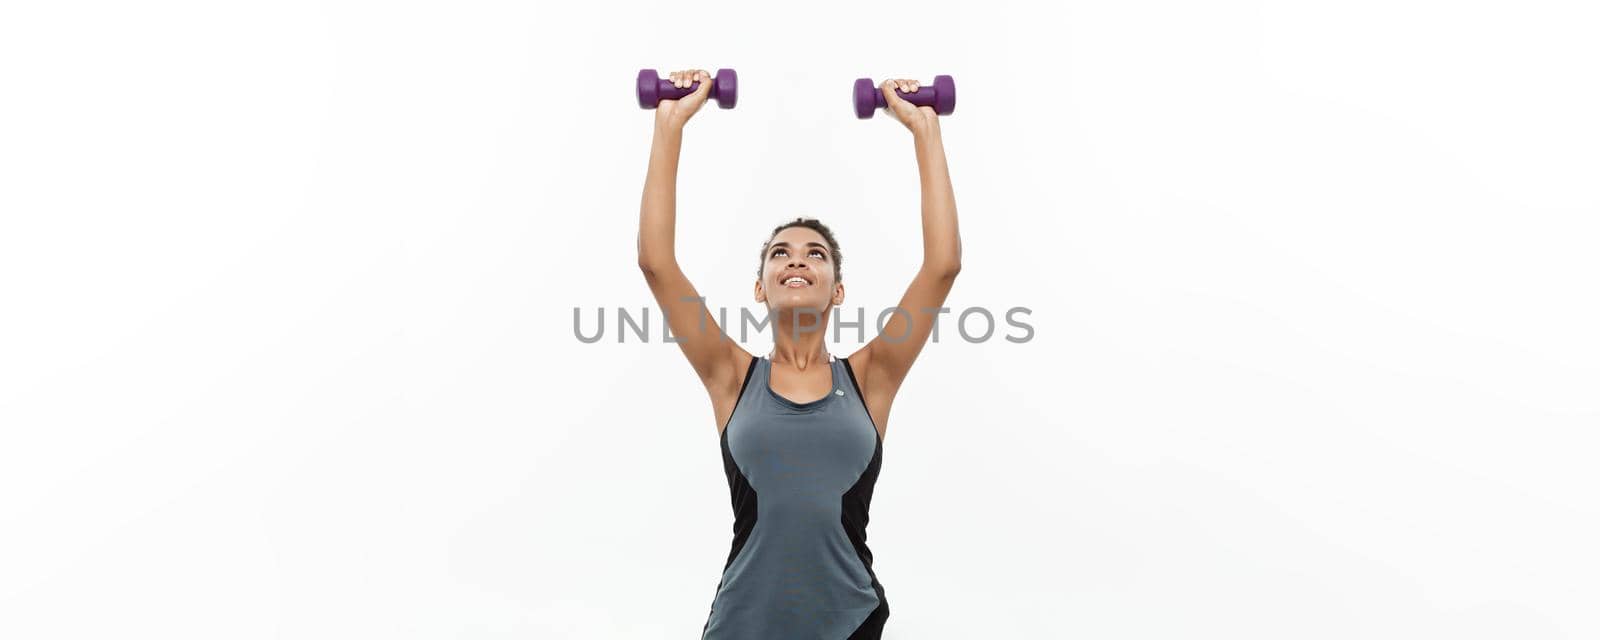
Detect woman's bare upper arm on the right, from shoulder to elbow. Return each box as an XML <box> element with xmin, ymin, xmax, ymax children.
<box><xmin>851</xmin><ymin>264</ymin><xmax>960</xmax><ymax>398</ymax></box>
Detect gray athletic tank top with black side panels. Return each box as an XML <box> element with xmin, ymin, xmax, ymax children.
<box><xmin>701</xmin><ymin>357</ymin><xmax>888</xmax><ymax>640</ymax></box>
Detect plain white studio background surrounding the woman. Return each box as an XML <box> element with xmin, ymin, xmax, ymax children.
<box><xmin>0</xmin><ymin>0</ymin><xmax>1600</xmax><ymax>640</ymax></box>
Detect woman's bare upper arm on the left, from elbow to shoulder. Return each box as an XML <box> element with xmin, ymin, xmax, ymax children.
<box><xmin>640</xmin><ymin>261</ymin><xmax>750</xmax><ymax>390</ymax></box>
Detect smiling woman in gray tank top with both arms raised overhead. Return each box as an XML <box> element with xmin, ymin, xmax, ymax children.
<box><xmin>638</xmin><ymin>69</ymin><xmax>962</xmax><ymax>640</ymax></box>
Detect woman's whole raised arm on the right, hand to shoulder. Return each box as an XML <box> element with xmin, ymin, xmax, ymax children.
<box><xmin>850</xmin><ymin>80</ymin><xmax>962</xmax><ymax>411</ymax></box>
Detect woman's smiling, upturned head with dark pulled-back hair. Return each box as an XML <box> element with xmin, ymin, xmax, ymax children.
<box><xmin>755</xmin><ymin>227</ymin><xmax>845</xmax><ymax>314</ymax></box>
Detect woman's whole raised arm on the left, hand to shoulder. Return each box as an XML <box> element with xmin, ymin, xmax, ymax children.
<box><xmin>638</xmin><ymin>70</ymin><xmax>749</xmax><ymax>390</ymax></box>
